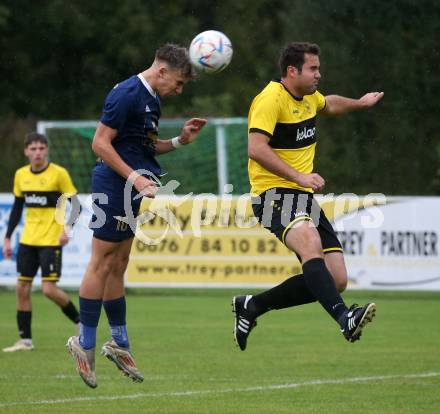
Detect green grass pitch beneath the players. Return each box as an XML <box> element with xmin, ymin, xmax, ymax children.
<box><xmin>0</xmin><ymin>289</ymin><xmax>440</xmax><ymax>414</ymax></box>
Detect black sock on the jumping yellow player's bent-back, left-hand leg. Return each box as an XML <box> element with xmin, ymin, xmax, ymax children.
<box><xmin>250</xmin><ymin>275</ymin><xmax>316</xmax><ymax>316</ymax></box>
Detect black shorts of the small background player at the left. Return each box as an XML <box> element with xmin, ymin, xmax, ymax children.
<box><xmin>17</xmin><ymin>243</ymin><xmax>62</xmax><ymax>282</ymax></box>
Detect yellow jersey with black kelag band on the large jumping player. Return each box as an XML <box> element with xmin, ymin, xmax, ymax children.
<box><xmin>248</xmin><ymin>81</ymin><xmax>325</xmax><ymax>194</ymax></box>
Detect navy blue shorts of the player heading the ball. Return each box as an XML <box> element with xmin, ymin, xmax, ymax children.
<box><xmin>89</xmin><ymin>163</ymin><xmax>142</xmax><ymax>242</ymax></box>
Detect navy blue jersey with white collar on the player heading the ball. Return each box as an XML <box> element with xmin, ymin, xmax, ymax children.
<box><xmin>101</xmin><ymin>75</ymin><xmax>161</xmax><ymax>176</ymax></box>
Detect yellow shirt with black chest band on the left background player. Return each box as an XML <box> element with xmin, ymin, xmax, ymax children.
<box><xmin>14</xmin><ymin>163</ymin><xmax>77</xmax><ymax>246</ymax></box>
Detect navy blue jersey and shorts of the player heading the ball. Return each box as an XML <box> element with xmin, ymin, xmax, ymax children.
<box><xmin>90</xmin><ymin>75</ymin><xmax>161</xmax><ymax>242</ymax></box>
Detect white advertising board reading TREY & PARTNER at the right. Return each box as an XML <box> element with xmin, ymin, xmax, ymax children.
<box><xmin>334</xmin><ymin>197</ymin><xmax>440</xmax><ymax>290</ymax></box>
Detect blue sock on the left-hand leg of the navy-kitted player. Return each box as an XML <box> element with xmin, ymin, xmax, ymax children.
<box><xmin>79</xmin><ymin>296</ymin><xmax>102</xmax><ymax>349</ymax></box>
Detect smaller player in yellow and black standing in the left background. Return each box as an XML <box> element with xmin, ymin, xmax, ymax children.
<box><xmin>3</xmin><ymin>132</ymin><xmax>80</xmax><ymax>352</ymax></box>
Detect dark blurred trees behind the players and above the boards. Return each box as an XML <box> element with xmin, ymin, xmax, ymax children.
<box><xmin>0</xmin><ymin>0</ymin><xmax>440</xmax><ymax>195</ymax></box>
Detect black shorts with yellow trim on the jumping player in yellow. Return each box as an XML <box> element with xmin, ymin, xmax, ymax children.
<box><xmin>252</xmin><ymin>188</ymin><xmax>343</xmax><ymax>253</ymax></box>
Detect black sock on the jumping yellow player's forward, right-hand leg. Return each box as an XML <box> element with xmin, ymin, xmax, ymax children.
<box><xmin>302</xmin><ymin>258</ymin><xmax>347</xmax><ymax>324</ymax></box>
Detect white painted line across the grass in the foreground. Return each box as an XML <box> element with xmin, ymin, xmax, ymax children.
<box><xmin>0</xmin><ymin>372</ymin><xmax>440</xmax><ymax>408</ymax></box>
